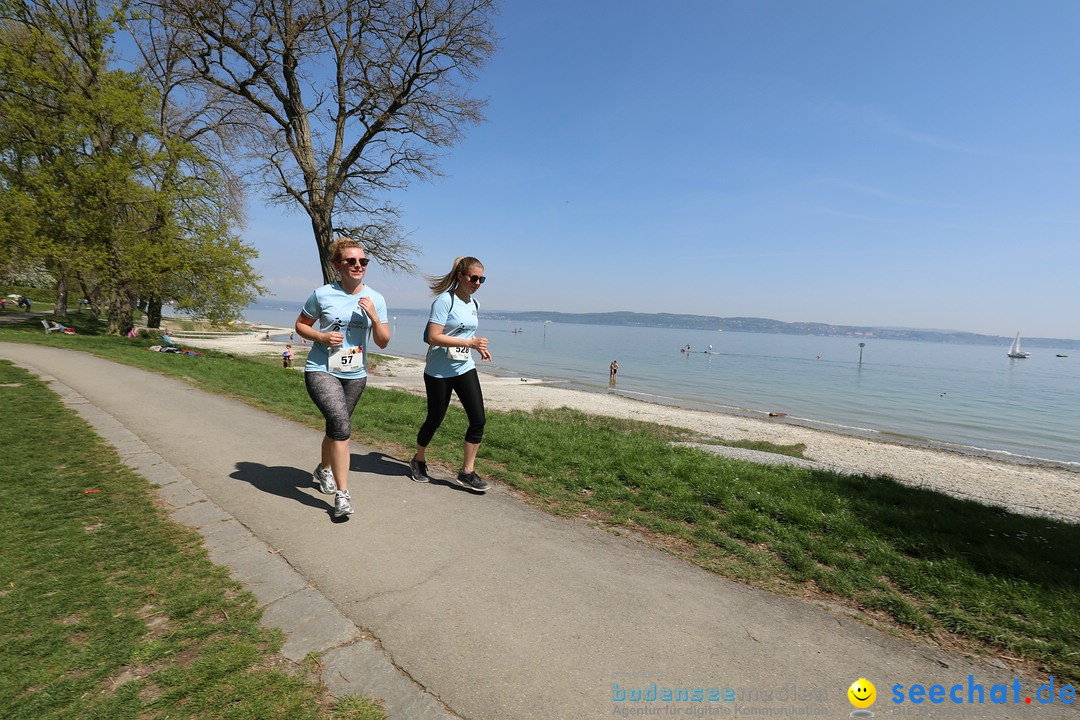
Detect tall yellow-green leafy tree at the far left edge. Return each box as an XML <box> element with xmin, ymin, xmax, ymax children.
<box><xmin>0</xmin><ymin>0</ymin><xmax>150</xmax><ymax>330</ymax></box>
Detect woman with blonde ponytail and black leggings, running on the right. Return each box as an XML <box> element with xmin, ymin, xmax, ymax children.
<box><xmin>409</xmin><ymin>257</ymin><xmax>491</xmax><ymax>492</ymax></box>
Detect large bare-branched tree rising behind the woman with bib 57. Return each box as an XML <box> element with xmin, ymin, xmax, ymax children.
<box><xmin>138</xmin><ymin>0</ymin><xmax>497</xmax><ymax>282</ymax></box>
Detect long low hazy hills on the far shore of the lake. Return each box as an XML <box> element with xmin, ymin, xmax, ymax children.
<box><xmin>484</xmin><ymin>311</ymin><xmax>1080</xmax><ymax>350</ymax></box>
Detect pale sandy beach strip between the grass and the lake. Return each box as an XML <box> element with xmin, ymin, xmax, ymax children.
<box><xmin>170</xmin><ymin>328</ymin><xmax>1080</xmax><ymax>522</ymax></box>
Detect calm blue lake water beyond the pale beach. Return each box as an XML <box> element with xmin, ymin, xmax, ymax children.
<box><xmin>247</xmin><ymin>302</ymin><xmax>1080</xmax><ymax>470</ymax></box>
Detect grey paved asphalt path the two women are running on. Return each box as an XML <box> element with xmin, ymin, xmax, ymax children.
<box><xmin>0</xmin><ymin>345</ymin><xmax>1080</xmax><ymax>720</ymax></box>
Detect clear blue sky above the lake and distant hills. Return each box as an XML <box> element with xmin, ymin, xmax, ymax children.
<box><xmin>244</xmin><ymin>0</ymin><xmax>1080</xmax><ymax>338</ymax></box>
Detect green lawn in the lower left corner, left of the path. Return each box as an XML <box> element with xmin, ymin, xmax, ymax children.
<box><xmin>0</xmin><ymin>362</ymin><xmax>384</xmax><ymax>720</ymax></box>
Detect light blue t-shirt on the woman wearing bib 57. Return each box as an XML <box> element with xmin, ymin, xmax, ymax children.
<box><xmin>300</xmin><ymin>283</ymin><xmax>387</xmax><ymax>379</ymax></box>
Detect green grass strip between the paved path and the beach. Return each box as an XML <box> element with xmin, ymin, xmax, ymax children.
<box><xmin>0</xmin><ymin>321</ymin><xmax>1080</xmax><ymax>682</ymax></box>
